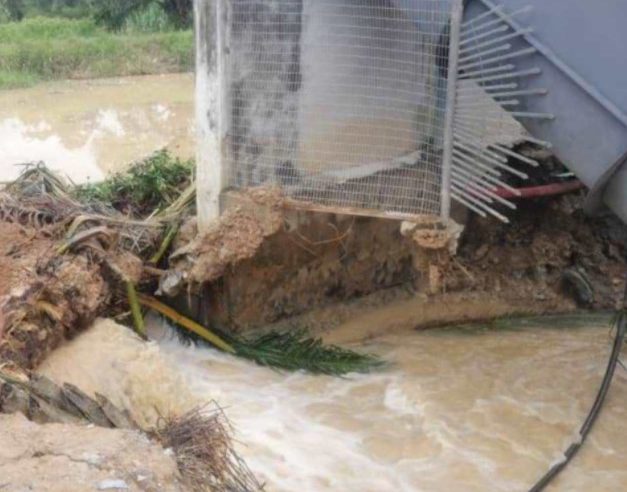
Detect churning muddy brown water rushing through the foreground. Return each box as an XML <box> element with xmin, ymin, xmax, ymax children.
<box><xmin>43</xmin><ymin>316</ymin><xmax>627</xmax><ymax>492</ymax></box>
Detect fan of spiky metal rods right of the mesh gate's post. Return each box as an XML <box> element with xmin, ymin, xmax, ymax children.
<box><xmin>451</xmin><ymin>3</ymin><xmax>553</xmax><ymax>222</ymax></box>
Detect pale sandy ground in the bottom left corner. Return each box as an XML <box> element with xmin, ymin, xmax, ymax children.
<box><xmin>0</xmin><ymin>414</ymin><xmax>189</xmax><ymax>492</ymax></box>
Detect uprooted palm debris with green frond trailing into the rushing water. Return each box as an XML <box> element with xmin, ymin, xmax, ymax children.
<box><xmin>0</xmin><ymin>156</ymin><xmax>382</xmax><ymax>375</ymax></box>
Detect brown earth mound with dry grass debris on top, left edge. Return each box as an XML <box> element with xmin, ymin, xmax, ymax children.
<box><xmin>0</xmin><ymin>163</ymin><xmax>193</xmax><ymax>368</ymax></box>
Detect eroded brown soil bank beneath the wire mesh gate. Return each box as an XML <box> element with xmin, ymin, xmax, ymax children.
<box><xmin>169</xmin><ymin>191</ymin><xmax>627</xmax><ymax>330</ymax></box>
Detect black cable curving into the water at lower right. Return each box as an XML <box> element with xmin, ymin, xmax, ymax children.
<box><xmin>529</xmin><ymin>276</ymin><xmax>627</xmax><ymax>492</ymax></box>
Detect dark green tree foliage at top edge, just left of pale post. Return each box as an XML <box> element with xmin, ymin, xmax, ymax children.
<box><xmin>94</xmin><ymin>0</ymin><xmax>194</xmax><ymax>30</ymax></box>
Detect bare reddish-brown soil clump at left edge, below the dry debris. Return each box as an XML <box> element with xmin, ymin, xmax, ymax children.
<box><xmin>0</xmin><ymin>222</ymin><xmax>110</xmax><ymax>369</ymax></box>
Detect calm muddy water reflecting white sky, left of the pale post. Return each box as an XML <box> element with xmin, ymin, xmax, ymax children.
<box><xmin>0</xmin><ymin>74</ymin><xmax>194</xmax><ymax>182</ymax></box>
